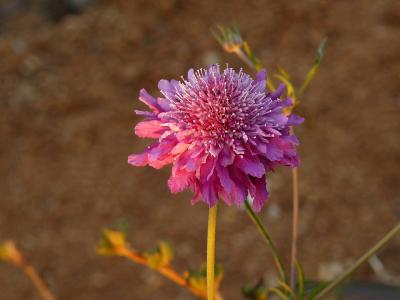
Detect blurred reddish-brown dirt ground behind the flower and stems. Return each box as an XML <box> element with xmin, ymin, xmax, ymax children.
<box><xmin>0</xmin><ymin>0</ymin><xmax>400</xmax><ymax>300</ymax></box>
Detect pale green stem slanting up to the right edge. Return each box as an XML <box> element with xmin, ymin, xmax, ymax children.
<box><xmin>314</xmin><ymin>223</ymin><xmax>400</xmax><ymax>300</ymax></box>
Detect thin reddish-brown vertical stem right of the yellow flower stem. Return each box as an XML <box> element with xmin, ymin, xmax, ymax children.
<box><xmin>290</xmin><ymin>164</ymin><xmax>300</xmax><ymax>289</ymax></box>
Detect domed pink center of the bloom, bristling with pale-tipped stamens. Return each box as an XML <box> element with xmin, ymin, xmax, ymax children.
<box><xmin>164</xmin><ymin>69</ymin><xmax>271</xmax><ymax>152</ymax></box>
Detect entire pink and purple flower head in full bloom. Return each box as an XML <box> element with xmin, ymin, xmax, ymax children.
<box><xmin>128</xmin><ymin>65</ymin><xmax>303</xmax><ymax>211</ymax></box>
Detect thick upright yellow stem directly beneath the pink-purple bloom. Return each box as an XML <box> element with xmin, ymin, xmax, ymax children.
<box><xmin>207</xmin><ymin>204</ymin><xmax>218</xmax><ymax>300</ymax></box>
